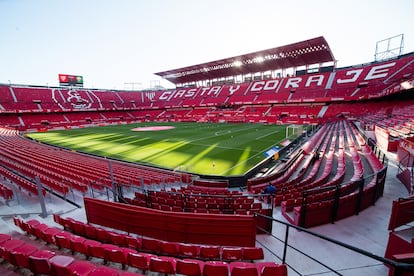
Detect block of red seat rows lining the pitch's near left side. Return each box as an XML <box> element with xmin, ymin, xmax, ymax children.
<box><xmin>0</xmin><ymin>129</ymin><xmax>188</xmax><ymax>195</ymax></box>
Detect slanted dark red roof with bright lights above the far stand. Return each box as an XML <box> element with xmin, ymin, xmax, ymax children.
<box><xmin>155</xmin><ymin>36</ymin><xmax>335</xmax><ymax>84</ymax></box>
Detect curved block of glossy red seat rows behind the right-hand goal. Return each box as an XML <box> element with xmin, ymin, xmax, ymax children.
<box><xmin>275</xmin><ymin>120</ymin><xmax>383</xmax><ymax>227</ymax></box>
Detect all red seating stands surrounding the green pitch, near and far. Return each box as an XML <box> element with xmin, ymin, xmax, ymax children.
<box><xmin>0</xmin><ymin>36</ymin><xmax>414</xmax><ymax>275</ymax></box>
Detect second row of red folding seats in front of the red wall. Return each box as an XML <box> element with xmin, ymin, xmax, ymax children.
<box><xmin>14</xmin><ymin>217</ymin><xmax>287</xmax><ymax>276</ymax></box>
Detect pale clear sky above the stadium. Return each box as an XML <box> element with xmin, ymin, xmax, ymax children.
<box><xmin>0</xmin><ymin>0</ymin><xmax>414</xmax><ymax>89</ymax></box>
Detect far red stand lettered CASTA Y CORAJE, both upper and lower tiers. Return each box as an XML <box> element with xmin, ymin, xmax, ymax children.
<box><xmin>0</xmin><ymin>49</ymin><xmax>414</xmax><ymax>130</ymax></box>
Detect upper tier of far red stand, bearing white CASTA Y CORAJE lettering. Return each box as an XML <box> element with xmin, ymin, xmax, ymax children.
<box><xmin>0</xmin><ymin>55</ymin><xmax>414</xmax><ymax>123</ymax></box>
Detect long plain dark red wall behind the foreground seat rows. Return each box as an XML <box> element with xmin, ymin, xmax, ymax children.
<box><xmin>84</xmin><ymin>197</ymin><xmax>256</xmax><ymax>246</ymax></box>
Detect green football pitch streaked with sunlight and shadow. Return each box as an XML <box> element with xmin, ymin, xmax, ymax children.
<box><xmin>28</xmin><ymin>122</ymin><xmax>300</xmax><ymax>176</ymax></box>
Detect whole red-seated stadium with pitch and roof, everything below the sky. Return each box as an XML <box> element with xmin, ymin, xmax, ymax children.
<box><xmin>0</xmin><ymin>25</ymin><xmax>414</xmax><ymax>276</ymax></box>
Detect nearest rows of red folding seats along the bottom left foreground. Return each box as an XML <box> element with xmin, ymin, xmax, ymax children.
<box><xmin>11</xmin><ymin>217</ymin><xmax>287</xmax><ymax>276</ymax></box>
